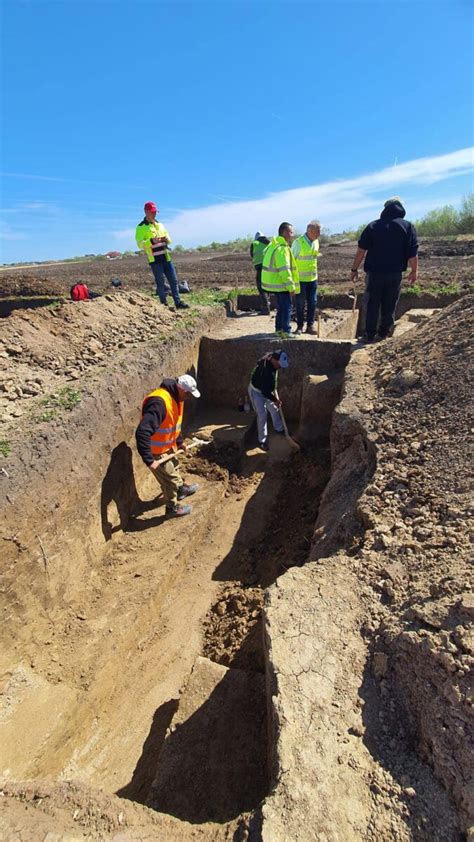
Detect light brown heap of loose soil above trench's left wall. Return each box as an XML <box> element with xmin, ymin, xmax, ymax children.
<box><xmin>0</xmin><ymin>292</ymin><xmax>186</xmax><ymax>437</ymax></box>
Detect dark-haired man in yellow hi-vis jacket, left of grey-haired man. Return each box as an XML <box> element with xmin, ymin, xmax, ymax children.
<box><xmin>262</xmin><ymin>222</ymin><xmax>300</xmax><ymax>337</ymax></box>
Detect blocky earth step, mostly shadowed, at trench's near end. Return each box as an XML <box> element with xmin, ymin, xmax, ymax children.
<box><xmin>146</xmin><ymin>657</ymin><xmax>267</xmax><ymax>823</ymax></box>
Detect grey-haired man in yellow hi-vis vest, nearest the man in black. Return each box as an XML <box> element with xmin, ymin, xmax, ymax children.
<box><xmin>291</xmin><ymin>219</ymin><xmax>321</xmax><ymax>335</ymax></box>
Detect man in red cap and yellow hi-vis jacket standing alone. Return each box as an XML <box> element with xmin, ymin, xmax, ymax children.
<box><xmin>135</xmin><ymin>202</ymin><xmax>189</xmax><ymax>310</ymax></box>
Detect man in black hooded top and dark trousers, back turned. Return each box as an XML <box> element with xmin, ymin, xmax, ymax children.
<box><xmin>351</xmin><ymin>196</ymin><xmax>418</xmax><ymax>342</ymax></box>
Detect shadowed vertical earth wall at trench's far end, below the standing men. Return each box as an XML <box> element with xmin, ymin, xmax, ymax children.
<box><xmin>199</xmin><ymin>337</ymin><xmax>351</xmax><ymax>421</ymax></box>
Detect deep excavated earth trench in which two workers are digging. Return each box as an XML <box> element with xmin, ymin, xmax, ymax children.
<box><xmin>1</xmin><ymin>320</ymin><xmax>350</xmax><ymax>838</ymax></box>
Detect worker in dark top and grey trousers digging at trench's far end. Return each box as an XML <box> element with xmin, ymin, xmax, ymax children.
<box><xmin>249</xmin><ymin>351</ymin><xmax>288</xmax><ymax>450</ymax></box>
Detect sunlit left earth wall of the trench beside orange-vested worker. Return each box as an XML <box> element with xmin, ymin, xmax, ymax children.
<box><xmin>0</xmin><ymin>310</ymin><xmax>225</xmax><ymax>617</ymax></box>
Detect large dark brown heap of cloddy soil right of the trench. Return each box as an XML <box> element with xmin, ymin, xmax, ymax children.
<box><xmin>357</xmin><ymin>296</ymin><xmax>474</xmax><ymax>824</ymax></box>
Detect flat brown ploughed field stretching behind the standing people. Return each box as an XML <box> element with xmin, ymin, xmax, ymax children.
<box><xmin>0</xmin><ymin>239</ymin><xmax>474</xmax><ymax>298</ymax></box>
